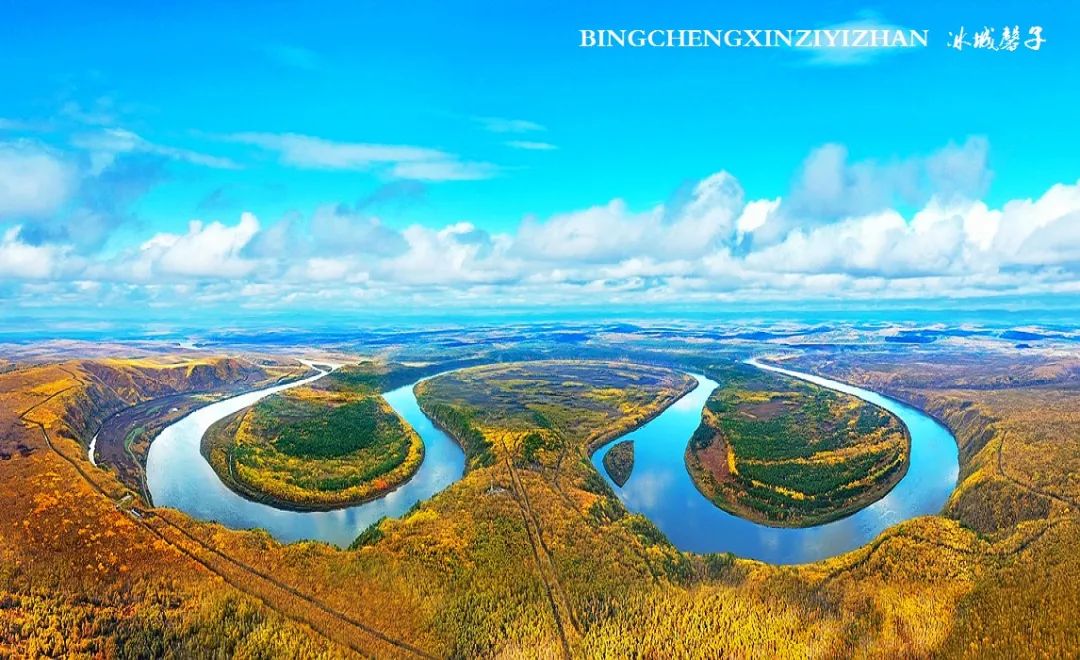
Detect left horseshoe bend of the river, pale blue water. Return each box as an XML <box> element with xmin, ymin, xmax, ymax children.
<box><xmin>146</xmin><ymin>376</ymin><xmax>465</xmax><ymax>545</ymax></box>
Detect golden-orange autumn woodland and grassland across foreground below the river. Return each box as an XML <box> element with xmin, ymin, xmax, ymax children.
<box><xmin>0</xmin><ymin>355</ymin><xmax>1080</xmax><ymax>658</ymax></box>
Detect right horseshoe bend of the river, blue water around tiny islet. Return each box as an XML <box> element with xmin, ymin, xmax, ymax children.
<box><xmin>592</xmin><ymin>363</ymin><xmax>959</xmax><ymax>564</ymax></box>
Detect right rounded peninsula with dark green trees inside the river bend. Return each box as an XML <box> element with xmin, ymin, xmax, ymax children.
<box><xmin>686</xmin><ymin>365</ymin><xmax>910</xmax><ymax>527</ymax></box>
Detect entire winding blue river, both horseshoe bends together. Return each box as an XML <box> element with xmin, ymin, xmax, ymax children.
<box><xmin>147</xmin><ymin>361</ymin><xmax>959</xmax><ymax>564</ymax></box>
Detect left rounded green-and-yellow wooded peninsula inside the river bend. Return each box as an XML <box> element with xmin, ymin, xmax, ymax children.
<box><xmin>202</xmin><ymin>367</ymin><xmax>423</xmax><ymax>510</ymax></box>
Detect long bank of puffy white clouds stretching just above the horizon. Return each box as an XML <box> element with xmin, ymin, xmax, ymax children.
<box><xmin>2</xmin><ymin>138</ymin><xmax>1080</xmax><ymax>313</ymax></box>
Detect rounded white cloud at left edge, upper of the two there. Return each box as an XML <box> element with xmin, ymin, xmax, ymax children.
<box><xmin>0</xmin><ymin>140</ymin><xmax>78</xmax><ymax>219</ymax></box>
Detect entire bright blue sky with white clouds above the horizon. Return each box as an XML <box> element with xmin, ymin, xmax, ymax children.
<box><xmin>0</xmin><ymin>0</ymin><xmax>1080</xmax><ymax>316</ymax></box>
